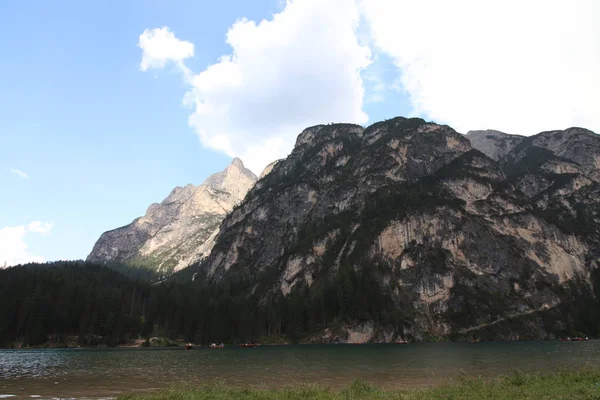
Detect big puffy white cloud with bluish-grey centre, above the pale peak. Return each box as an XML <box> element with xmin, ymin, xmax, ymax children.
<box><xmin>142</xmin><ymin>0</ymin><xmax>371</xmax><ymax>173</ymax></box>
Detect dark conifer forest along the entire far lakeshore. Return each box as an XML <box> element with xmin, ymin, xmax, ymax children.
<box><xmin>0</xmin><ymin>260</ymin><xmax>600</xmax><ymax>347</ymax></box>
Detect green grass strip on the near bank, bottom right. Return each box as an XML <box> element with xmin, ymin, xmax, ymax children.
<box><xmin>120</xmin><ymin>369</ymin><xmax>600</xmax><ymax>400</ymax></box>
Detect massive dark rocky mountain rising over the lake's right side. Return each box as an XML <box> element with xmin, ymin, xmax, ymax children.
<box><xmin>194</xmin><ymin>118</ymin><xmax>600</xmax><ymax>341</ymax></box>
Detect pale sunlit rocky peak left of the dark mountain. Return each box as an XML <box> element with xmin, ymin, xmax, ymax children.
<box><xmin>87</xmin><ymin>158</ymin><xmax>256</xmax><ymax>273</ymax></box>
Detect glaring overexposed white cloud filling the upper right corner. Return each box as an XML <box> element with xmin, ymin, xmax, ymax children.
<box><xmin>361</xmin><ymin>0</ymin><xmax>600</xmax><ymax>135</ymax></box>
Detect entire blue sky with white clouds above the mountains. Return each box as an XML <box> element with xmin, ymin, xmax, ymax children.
<box><xmin>0</xmin><ymin>0</ymin><xmax>600</xmax><ymax>267</ymax></box>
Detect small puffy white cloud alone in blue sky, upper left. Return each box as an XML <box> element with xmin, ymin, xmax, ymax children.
<box><xmin>138</xmin><ymin>26</ymin><xmax>194</xmax><ymax>71</ymax></box>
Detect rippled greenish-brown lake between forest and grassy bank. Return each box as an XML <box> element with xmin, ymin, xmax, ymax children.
<box><xmin>0</xmin><ymin>340</ymin><xmax>600</xmax><ymax>400</ymax></box>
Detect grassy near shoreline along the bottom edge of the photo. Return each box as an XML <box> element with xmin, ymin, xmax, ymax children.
<box><xmin>0</xmin><ymin>367</ymin><xmax>600</xmax><ymax>400</ymax></box>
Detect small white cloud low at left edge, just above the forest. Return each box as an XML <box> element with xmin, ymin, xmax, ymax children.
<box><xmin>0</xmin><ymin>221</ymin><xmax>54</xmax><ymax>268</ymax></box>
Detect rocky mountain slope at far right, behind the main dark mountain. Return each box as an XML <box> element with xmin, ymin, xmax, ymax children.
<box><xmin>472</xmin><ymin>128</ymin><xmax>600</xmax><ymax>268</ymax></box>
